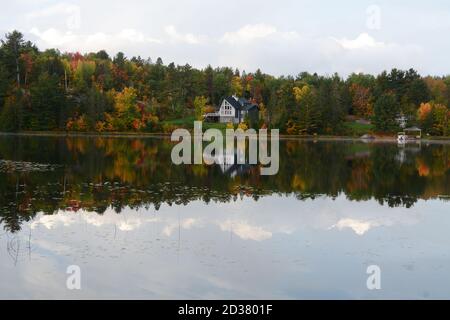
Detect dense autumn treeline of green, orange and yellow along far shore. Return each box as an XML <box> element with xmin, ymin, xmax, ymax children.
<box><xmin>0</xmin><ymin>31</ymin><xmax>450</xmax><ymax>136</ymax></box>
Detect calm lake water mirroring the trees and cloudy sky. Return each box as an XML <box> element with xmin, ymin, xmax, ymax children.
<box><xmin>0</xmin><ymin>137</ymin><xmax>450</xmax><ymax>299</ymax></box>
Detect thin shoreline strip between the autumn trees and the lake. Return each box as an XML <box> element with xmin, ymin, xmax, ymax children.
<box><xmin>0</xmin><ymin>131</ymin><xmax>450</xmax><ymax>144</ymax></box>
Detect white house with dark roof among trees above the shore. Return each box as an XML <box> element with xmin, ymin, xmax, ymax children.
<box><xmin>205</xmin><ymin>96</ymin><xmax>259</xmax><ymax>123</ymax></box>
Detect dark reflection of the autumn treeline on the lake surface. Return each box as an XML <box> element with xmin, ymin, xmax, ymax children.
<box><xmin>0</xmin><ymin>137</ymin><xmax>450</xmax><ymax>232</ymax></box>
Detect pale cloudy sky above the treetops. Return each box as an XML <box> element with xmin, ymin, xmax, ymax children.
<box><xmin>0</xmin><ymin>0</ymin><xmax>450</xmax><ymax>76</ymax></box>
